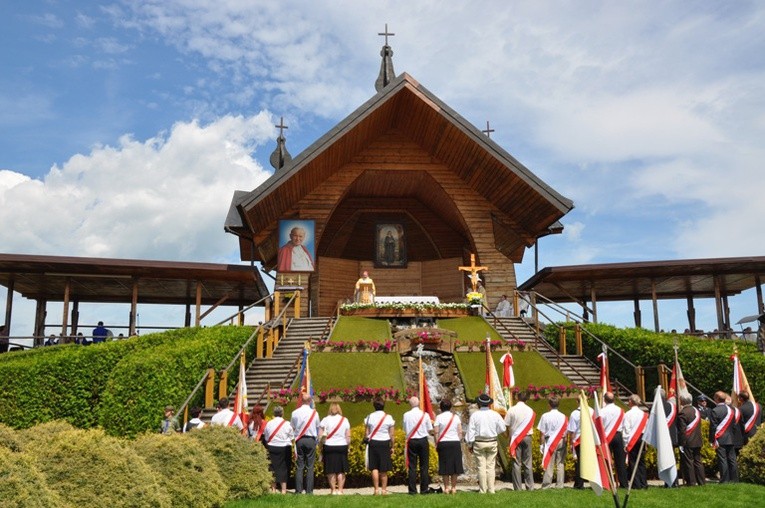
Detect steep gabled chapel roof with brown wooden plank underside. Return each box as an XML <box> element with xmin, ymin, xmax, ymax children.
<box><xmin>226</xmin><ymin>73</ymin><xmax>573</xmax><ymax>261</ymax></box>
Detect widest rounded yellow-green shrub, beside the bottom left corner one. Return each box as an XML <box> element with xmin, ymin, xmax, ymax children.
<box><xmin>25</xmin><ymin>429</ymin><xmax>170</xmax><ymax>508</ymax></box>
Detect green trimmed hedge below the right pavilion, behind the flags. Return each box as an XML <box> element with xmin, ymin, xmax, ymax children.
<box><xmin>544</xmin><ymin>323</ymin><xmax>765</xmax><ymax>400</ymax></box>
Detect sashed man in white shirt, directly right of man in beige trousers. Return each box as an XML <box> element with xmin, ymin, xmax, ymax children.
<box><xmin>505</xmin><ymin>390</ymin><xmax>536</xmax><ymax>490</ymax></box>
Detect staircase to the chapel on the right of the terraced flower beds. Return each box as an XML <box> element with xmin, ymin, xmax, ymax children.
<box><xmin>487</xmin><ymin>317</ymin><xmax>630</xmax><ymax>401</ymax></box>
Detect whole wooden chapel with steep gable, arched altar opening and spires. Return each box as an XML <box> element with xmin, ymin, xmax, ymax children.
<box><xmin>225</xmin><ymin>35</ymin><xmax>573</xmax><ymax>316</ymax></box>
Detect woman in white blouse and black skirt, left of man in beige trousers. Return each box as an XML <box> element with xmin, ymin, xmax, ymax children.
<box><xmin>434</xmin><ymin>399</ymin><xmax>465</xmax><ymax>494</ymax></box>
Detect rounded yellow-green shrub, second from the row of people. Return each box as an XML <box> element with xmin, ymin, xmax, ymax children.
<box><xmin>131</xmin><ymin>434</ymin><xmax>227</xmax><ymax>508</ymax></box>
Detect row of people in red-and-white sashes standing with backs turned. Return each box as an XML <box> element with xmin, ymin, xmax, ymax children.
<box><xmin>161</xmin><ymin>390</ymin><xmax>762</xmax><ymax>495</ymax></box>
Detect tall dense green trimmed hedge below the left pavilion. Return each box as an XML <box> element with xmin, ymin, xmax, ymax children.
<box><xmin>0</xmin><ymin>327</ymin><xmax>255</xmax><ymax>436</ymax></box>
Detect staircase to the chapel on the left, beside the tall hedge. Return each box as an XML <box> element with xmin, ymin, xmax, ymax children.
<box><xmin>201</xmin><ymin>318</ymin><xmax>333</xmax><ymax>421</ymax></box>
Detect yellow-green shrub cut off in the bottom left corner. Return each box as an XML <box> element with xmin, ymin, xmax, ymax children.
<box><xmin>0</xmin><ymin>447</ymin><xmax>67</xmax><ymax>508</ymax></box>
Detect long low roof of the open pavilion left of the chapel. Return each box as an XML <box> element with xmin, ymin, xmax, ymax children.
<box><xmin>0</xmin><ymin>254</ymin><xmax>269</xmax><ymax>305</ymax></box>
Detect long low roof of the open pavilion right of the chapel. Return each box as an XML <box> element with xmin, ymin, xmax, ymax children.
<box><xmin>518</xmin><ymin>257</ymin><xmax>765</xmax><ymax>302</ymax></box>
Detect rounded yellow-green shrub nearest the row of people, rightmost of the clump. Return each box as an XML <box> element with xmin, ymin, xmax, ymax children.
<box><xmin>188</xmin><ymin>425</ymin><xmax>273</xmax><ymax>500</ymax></box>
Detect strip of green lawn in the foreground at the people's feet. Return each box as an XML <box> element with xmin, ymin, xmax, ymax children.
<box><xmin>225</xmin><ymin>480</ymin><xmax>765</xmax><ymax>508</ymax></box>
